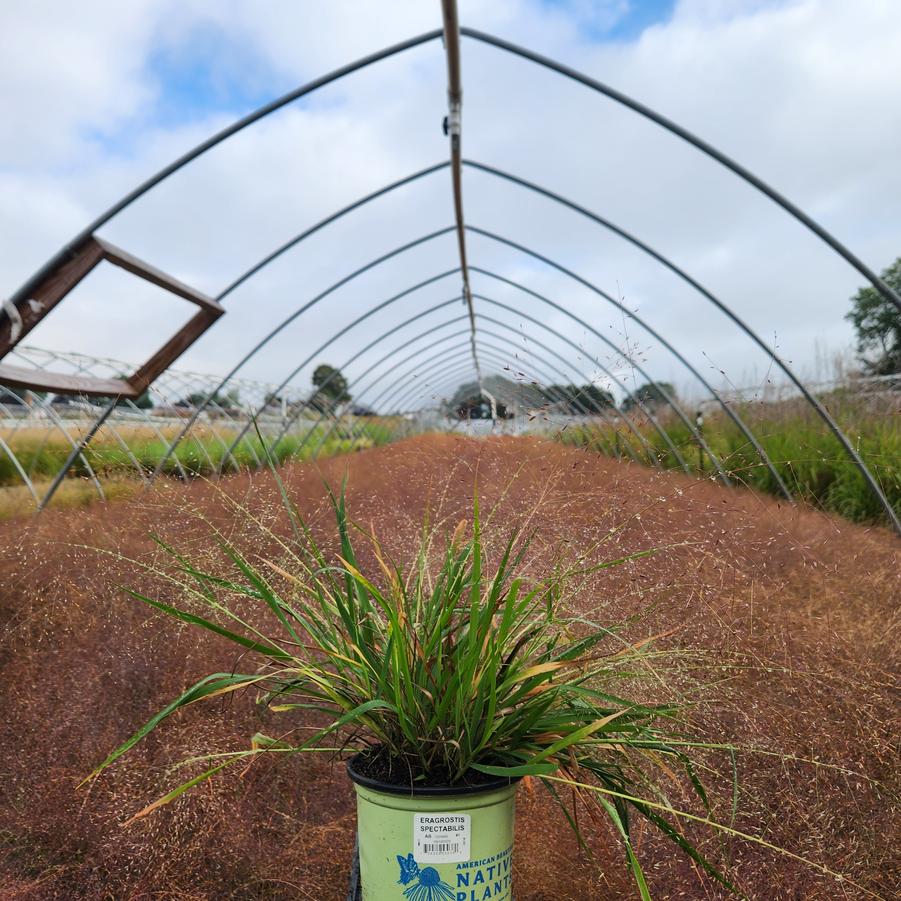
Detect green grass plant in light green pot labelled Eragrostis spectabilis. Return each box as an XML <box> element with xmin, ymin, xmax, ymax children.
<box><xmin>89</xmin><ymin>474</ymin><xmax>732</xmax><ymax>901</ymax></box>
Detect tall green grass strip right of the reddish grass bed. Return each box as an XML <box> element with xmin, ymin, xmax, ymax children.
<box><xmin>555</xmin><ymin>392</ymin><xmax>901</xmax><ymax>522</ymax></box>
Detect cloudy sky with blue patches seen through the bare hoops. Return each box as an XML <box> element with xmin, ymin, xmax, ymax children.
<box><xmin>0</xmin><ymin>0</ymin><xmax>901</xmax><ymax>408</ymax></box>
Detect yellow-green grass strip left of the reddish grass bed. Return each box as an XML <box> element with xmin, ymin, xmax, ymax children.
<box><xmin>0</xmin><ymin>417</ymin><xmax>399</xmax><ymax>518</ymax></box>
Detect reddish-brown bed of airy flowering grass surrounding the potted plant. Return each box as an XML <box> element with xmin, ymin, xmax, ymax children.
<box><xmin>0</xmin><ymin>435</ymin><xmax>901</xmax><ymax>901</ymax></box>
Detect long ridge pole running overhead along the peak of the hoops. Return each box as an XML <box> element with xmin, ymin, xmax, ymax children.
<box><xmin>441</xmin><ymin>0</ymin><xmax>482</xmax><ymax>393</ymax></box>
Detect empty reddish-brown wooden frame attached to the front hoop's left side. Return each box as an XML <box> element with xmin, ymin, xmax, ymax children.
<box><xmin>0</xmin><ymin>236</ymin><xmax>225</xmax><ymax>397</ymax></box>
